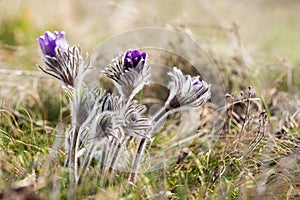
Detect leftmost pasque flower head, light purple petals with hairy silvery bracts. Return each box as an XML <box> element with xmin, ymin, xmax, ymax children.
<box><xmin>38</xmin><ymin>31</ymin><xmax>86</xmax><ymax>87</ymax></box>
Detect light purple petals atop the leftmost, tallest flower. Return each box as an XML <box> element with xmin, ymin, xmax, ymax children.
<box><xmin>38</xmin><ymin>31</ymin><xmax>69</xmax><ymax>57</ymax></box>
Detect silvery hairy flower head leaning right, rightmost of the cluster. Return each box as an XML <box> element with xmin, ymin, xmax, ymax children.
<box><xmin>166</xmin><ymin>67</ymin><xmax>211</xmax><ymax>109</ymax></box>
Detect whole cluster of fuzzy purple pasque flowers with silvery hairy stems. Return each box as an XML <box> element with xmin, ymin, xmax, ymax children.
<box><xmin>38</xmin><ymin>32</ymin><xmax>210</xmax><ymax>184</ymax></box>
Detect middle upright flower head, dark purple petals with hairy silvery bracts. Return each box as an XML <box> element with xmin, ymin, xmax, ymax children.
<box><xmin>104</xmin><ymin>50</ymin><xmax>150</xmax><ymax>100</ymax></box>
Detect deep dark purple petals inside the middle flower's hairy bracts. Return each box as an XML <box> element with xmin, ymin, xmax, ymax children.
<box><xmin>123</xmin><ymin>49</ymin><xmax>147</xmax><ymax>72</ymax></box>
